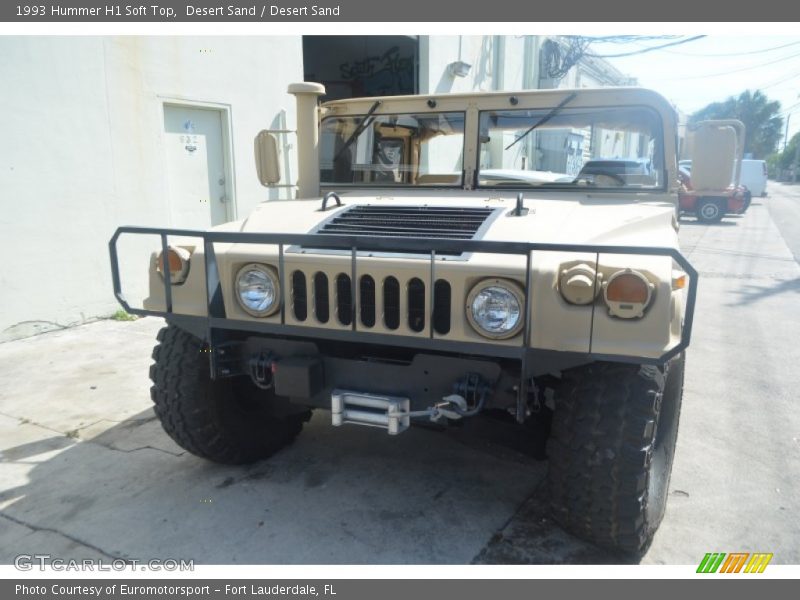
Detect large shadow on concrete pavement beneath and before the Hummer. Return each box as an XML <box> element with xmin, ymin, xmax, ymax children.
<box><xmin>0</xmin><ymin>409</ymin><xmax>621</xmax><ymax>564</ymax></box>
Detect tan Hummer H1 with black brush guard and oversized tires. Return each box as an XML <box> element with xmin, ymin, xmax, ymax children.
<box><xmin>110</xmin><ymin>83</ymin><xmax>697</xmax><ymax>553</ymax></box>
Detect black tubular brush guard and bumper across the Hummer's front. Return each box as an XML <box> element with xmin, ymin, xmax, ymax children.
<box><xmin>109</xmin><ymin>227</ymin><xmax>697</xmax><ymax>424</ymax></box>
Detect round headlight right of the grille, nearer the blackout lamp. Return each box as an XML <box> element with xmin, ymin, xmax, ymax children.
<box><xmin>467</xmin><ymin>279</ymin><xmax>525</xmax><ymax>339</ymax></box>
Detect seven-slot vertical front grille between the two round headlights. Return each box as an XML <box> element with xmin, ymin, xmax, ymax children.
<box><xmin>289</xmin><ymin>270</ymin><xmax>452</xmax><ymax>335</ymax></box>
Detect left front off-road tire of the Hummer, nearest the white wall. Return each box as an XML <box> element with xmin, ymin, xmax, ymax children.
<box><xmin>150</xmin><ymin>325</ymin><xmax>311</xmax><ymax>464</ymax></box>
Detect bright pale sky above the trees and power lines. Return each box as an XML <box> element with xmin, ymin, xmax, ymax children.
<box><xmin>589</xmin><ymin>35</ymin><xmax>800</xmax><ymax>149</ymax></box>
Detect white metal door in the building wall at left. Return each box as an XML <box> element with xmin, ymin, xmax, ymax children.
<box><xmin>164</xmin><ymin>104</ymin><xmax>230</xmax><ymax>229</ymax></box>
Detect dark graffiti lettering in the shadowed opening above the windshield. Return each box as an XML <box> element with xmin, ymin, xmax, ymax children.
<box><xmin>339</xmin><ymin>46</ymin><xmax>414</xmax><ymax>96</ymax></box>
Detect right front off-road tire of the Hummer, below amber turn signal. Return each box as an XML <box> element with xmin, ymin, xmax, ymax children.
<box><xmin>547</xmin><ymin>354</ymin><xmax>685</xmax><ymax>556</ymax></box>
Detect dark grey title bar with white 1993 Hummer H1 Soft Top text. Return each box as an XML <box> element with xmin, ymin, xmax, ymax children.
<box><xmin>0</xmin><ymin>0</ymin><xmax>800</xmax><ymax>22</ymax></box>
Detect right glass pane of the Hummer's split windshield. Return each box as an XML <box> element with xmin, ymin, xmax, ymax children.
<box><xmin>478</xmin><ymin>106</ymin><xmax>664</xmax><ymax>190</ymax></box>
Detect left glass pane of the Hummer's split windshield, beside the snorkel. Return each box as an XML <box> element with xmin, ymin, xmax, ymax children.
<box><xmin>320</xmin><ymin>113</ymin><xmax>464</xmax><ymax>186</ymax></box>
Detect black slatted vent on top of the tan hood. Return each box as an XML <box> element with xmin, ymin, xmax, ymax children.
<box><xmin>315</xmin><ymin>205</ymin><xmax>493</xmax><ymax>240</ymax></box>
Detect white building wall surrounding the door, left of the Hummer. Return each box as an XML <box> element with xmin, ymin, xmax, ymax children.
<box><xmin>0</xmin><ymin>36</ymin><xmax>303</xmax><ymax>341</ymax></box>
